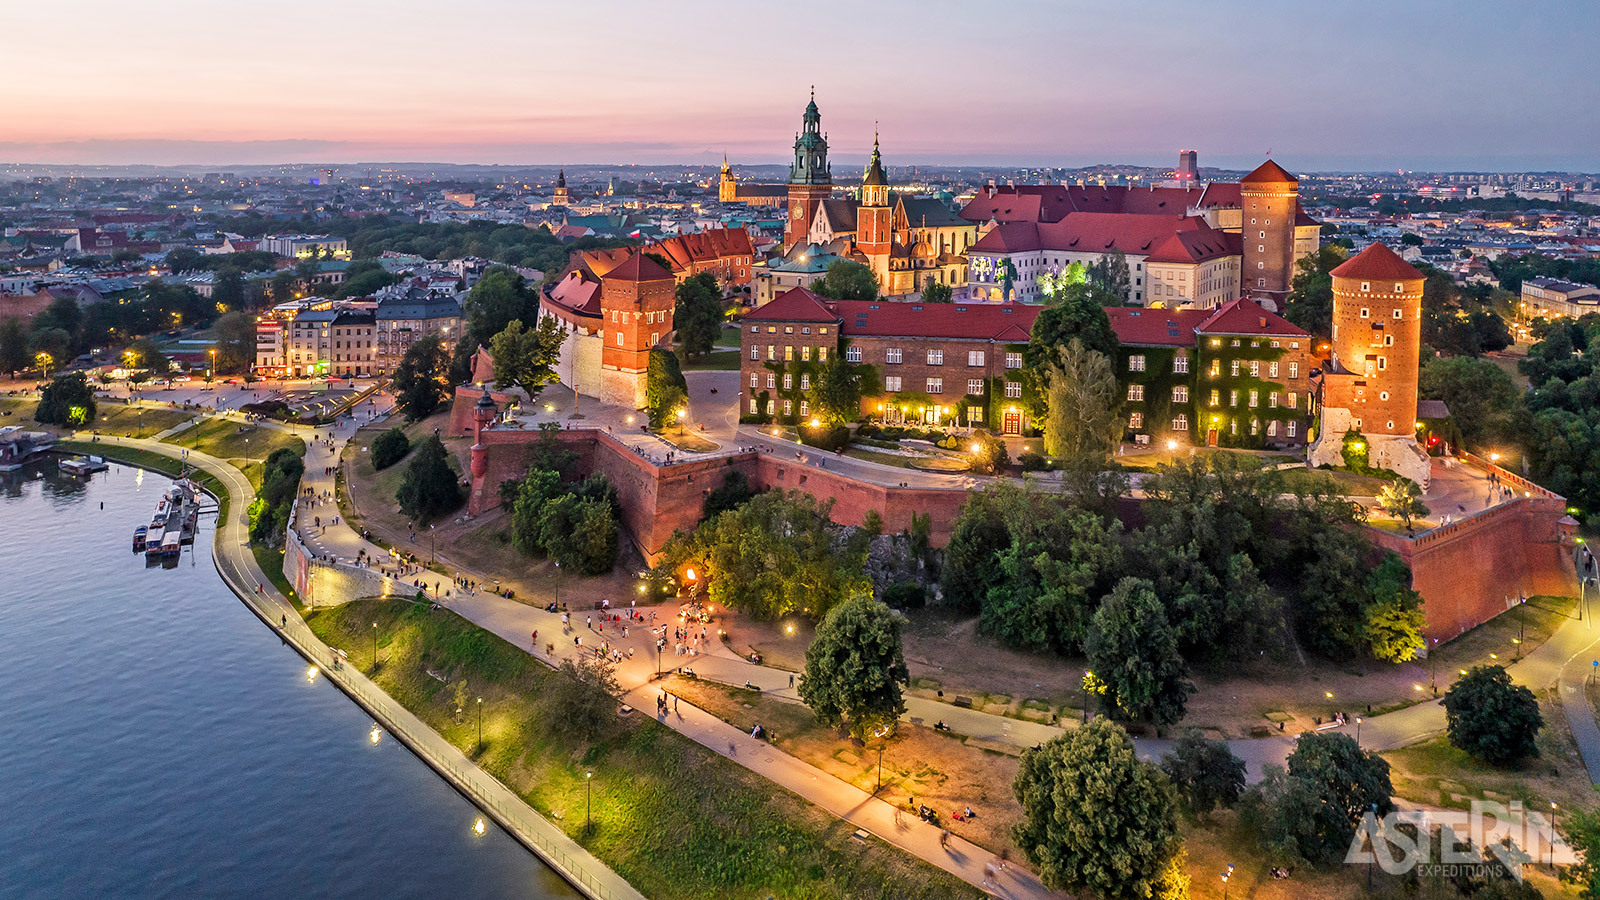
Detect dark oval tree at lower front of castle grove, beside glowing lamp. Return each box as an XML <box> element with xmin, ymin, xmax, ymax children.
<box><xmin>1083</xmin><ymin>578</ymin><xmax>1195</xmax><ymax>729</ymax></box>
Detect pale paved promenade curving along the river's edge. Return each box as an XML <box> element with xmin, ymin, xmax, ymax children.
<box><xmin>78</xmin><ymin>436</ymin><xmax>645</xmax><ymax>900</ymax></box>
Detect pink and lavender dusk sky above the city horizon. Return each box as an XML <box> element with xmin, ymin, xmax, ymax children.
<box><xmin>0</xmin><ymin>0</ymin><xmax>1600</xmax><ymax>175</ymax></box>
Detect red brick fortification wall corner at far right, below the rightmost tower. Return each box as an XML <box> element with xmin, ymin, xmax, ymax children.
<box><xmin>1370</xmin><ymin>495</ymin><xmax>1578</xmax><ymax>641</ymax></box>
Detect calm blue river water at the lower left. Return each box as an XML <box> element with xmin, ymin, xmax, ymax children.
<box><xmin>0</xmin><ymin>458</ymin><xmax>578</xmax><ymax>900</ymax></box>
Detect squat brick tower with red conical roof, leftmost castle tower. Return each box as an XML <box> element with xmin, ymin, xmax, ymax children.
<box><xmin>598</xmin><ymin>253</ymin><xmax>677</xmax><ymax>410</ymax></box>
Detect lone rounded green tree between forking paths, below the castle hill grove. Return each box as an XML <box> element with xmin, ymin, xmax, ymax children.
<box><xmin>798</xmin><ymin>593</ymin><xmax>910</xmax><ymax>740</ymax></box>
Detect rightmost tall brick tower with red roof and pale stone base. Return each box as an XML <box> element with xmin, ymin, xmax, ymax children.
<box><xmin>1305</xmin><ymin>241</ymin><xmax>1429</xmax><ymax>485</ymax></box>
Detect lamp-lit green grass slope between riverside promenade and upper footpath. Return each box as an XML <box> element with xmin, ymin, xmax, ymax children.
<box><xmin>300</xmin><ymin>599</ymin><xmax>979</xmax><ymax>900</ymax></box>
